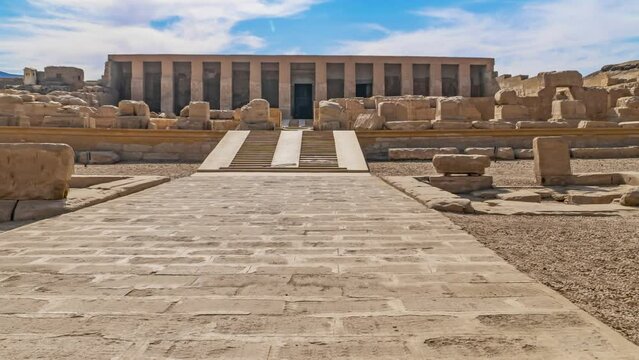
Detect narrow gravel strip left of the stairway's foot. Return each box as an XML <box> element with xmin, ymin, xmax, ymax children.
<box><xmin>75</xmin><ymin>162</ymin><xmax>200</xmax><ymax>179</ymax></box>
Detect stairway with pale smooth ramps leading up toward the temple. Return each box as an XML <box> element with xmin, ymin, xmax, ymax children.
<box><xmin>198</xmin><ymin>130</ymin><xmax>368</xmax><ymax>173</ymax></box>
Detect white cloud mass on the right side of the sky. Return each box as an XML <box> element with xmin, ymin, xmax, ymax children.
<box><xmin>334</xmin><ymin>0</ymin><xmax>639</xmax><ymax>74</ymax></box>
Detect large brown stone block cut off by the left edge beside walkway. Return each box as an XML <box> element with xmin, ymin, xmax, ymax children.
<box><xmin>0</xmin><ymin>143</ymin><xmax>75</xmax><ymax>200</ymax></box>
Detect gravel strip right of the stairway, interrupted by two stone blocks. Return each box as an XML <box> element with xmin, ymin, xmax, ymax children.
<box><xmin>368</xmin><ymin>159</ymin><xmax>639</xmax><ymax>186</ymax></box>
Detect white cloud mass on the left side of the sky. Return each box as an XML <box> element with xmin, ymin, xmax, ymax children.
<box><xmin>0</xmin><ymin>0</ymin><xmax>321</xmax><ymax>78</ymax></box>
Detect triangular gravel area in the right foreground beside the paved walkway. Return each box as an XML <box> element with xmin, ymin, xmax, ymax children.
<box><xmin>445</xmin><ymin>214</ymin><xmax>639</xmax><ymax>345</ymax></box>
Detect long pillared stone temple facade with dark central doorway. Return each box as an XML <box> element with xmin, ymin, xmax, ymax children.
<box><xmin>104</xmin><ymin>55</ymin><xmax>496</xmax><ymax>119</ymax></box>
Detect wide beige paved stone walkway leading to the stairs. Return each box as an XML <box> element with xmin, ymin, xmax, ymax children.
<box><xmin>0</xmin><ymin>174</ymin><xmax>639</xmax><ymax>360</ymax></box>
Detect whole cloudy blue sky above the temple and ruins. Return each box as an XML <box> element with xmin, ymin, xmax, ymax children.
<box><xmin>0</xmin><ymin>0</ymin><xmax>639</xmax><ymax>78</ymax></box>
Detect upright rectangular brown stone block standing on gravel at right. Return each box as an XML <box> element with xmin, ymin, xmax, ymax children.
<box><xmin>533</xmin><ymin>136</ymin><xmax>572</xmax><ymax>185</ymax></box>
